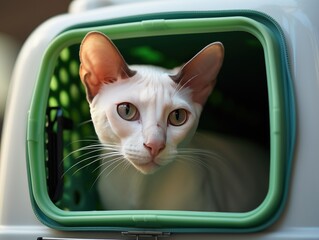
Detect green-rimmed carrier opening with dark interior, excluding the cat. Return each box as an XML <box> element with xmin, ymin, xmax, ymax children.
<box><xmin>27</xmin><ymin>11</ymin><xmax>295</xmax><ymax>232</ymax></box>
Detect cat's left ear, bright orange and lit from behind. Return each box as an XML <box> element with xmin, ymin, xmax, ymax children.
<box><xmin>79</xmin><ymin>32</ymin><xmax>135</xmax><ymax>102</ymax></box>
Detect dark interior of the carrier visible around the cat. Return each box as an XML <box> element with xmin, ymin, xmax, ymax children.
<box><xmin>46</xmin><ymin>32</ymin><xmax>270</xmax><ymax>211</ymax></box>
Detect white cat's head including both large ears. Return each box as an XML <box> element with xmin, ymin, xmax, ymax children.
<box><xmin>80</xmin><ymin>32</ymin><xmax>224</xmax><ymax>174</ymax></box>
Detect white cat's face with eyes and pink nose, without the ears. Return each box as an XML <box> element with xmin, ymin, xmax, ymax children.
<box><xmin>90</xmin><ymin>66</ymin><xmax>202</xmax><ymax>173</ymax></box>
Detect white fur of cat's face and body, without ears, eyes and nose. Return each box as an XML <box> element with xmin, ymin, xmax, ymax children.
<box><xmin>90</xmin><ymin>66</ymin><xmax>268</xmax><ymax>211</ymax></box>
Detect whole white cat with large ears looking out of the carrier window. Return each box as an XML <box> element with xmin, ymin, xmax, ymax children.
<box><xmin>79</xmin><ymin>32</ymin><xmax>269</xmax><ymax>212</ymax></box>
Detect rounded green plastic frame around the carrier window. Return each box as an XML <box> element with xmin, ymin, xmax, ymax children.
<box><xmin>27</xmin><ymin>16</ymin><xmax>294</xmax><ymax>232</ymax></box>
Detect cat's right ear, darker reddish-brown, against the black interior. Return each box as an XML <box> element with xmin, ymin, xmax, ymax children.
<box><xmin>170</xmin><ymin>42</ymin><xmax>224</xmax><ymax>105</ymax></box>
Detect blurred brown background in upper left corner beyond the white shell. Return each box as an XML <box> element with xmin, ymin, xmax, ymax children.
<box><xmin>0</xmin><ymin>0</ymin><xmax>71</xmax><ymax>149</ymax></box>
